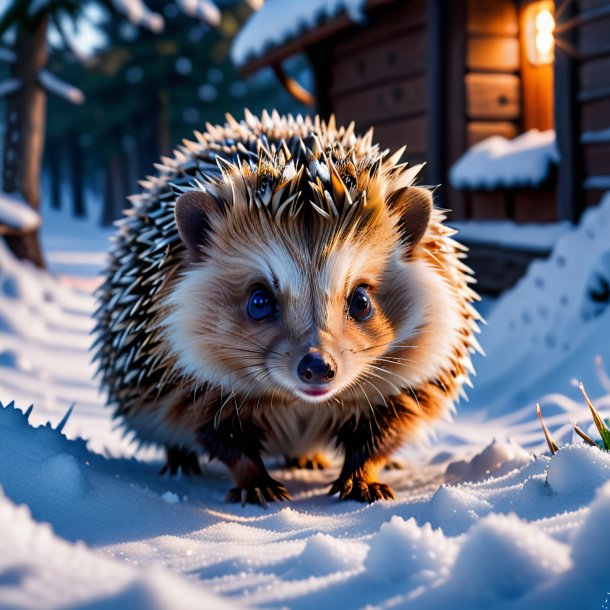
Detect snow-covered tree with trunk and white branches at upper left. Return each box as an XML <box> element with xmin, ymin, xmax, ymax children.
<box><xmin>0</xmin><ymin>0</ymin><xmax>220</xmax><ymax>267</ymax></box>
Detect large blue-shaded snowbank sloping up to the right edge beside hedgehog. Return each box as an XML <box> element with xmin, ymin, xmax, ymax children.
<box><xmin>469</xmin><ymin>194</ymin><xmax>610</xmax><ymax>422</ymax></box>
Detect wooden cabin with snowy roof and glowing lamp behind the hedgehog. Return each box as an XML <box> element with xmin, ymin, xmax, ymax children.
<box><xmin>233</xmin><ymin>0</ymin><xmax>610</xmax><ymax>292</ymax></box>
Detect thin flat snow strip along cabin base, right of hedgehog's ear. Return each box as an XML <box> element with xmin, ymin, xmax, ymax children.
<box><xmin>451</xmin><ymin>220</ymin><xmax>572</xmax><ymax>252</ymax></box>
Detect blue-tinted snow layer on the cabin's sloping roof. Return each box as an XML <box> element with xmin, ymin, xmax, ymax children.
<box><xmin>231</xmin><ymin>0</ymin><xmax>366</xmax><ymax>66</ymax></box>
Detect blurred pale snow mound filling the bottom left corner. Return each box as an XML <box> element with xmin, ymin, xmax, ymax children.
<box><xmin>0</xmin><ymin>488</ymin><xmax>240</xmax><ymax>610</ymax></box>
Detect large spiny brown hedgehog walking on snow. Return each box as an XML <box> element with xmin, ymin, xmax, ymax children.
<box><xmin>94</xmin><ymin>110</ymin><xmax>480</xmax><ymax>506</ymax></box>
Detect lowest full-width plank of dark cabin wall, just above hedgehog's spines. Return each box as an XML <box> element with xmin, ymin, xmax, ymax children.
<box><xmin>333</xmin><ymin>76</ymin><xmax>426</xmax><ymax>125</ymax></box>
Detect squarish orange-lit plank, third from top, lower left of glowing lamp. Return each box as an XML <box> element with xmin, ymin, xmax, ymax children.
<box><xmin>465</xmin><ymin>72</ymin><xmax>521</xmax><ymax>119</ymax></box>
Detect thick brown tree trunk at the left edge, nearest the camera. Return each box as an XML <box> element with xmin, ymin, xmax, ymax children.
<box><xmin>3</xmin><ymin>18</ymin><xmax>48</xmax><ymax>267</ymax></box>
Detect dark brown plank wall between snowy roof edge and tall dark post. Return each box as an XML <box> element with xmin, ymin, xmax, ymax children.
<box><xmin>326</xmin><ymin>0</ymin><xmax>428</xmax><ymax>169</ymax></box>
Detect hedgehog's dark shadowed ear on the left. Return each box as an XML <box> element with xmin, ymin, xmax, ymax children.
<box><xmin>175</xmin><ymin>191</ymin><xmax>220</xmax><ymax>256</ymax></box>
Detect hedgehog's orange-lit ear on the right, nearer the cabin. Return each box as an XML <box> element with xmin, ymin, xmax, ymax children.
<box><xmin>387</xmin><ymin>186</ymin><xmax>434</xmax><ymax>252</ymax></box>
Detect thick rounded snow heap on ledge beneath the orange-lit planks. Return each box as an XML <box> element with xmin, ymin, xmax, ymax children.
<box><xmin>449</xmin><ymin>129</ymin><xmax>559</xmax><ymax>190</ymax></box>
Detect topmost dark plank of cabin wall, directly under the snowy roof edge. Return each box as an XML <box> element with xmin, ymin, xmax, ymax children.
<box><xmin>333</xmin><ymin>0</ymin><xmax>426</xmax><ymax>60</ymax></box>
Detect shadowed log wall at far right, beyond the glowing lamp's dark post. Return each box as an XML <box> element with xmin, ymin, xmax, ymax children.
<box><xmin>575</xmin><ymin>0</ymin><xmax>610</xmax><ymax>206</ymax></box>
